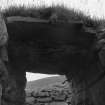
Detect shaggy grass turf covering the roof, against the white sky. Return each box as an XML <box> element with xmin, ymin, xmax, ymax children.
<box><xmin>2</xmin><ymin>5</ymin><xmax>105</xmax><ymax>26</ymax></box>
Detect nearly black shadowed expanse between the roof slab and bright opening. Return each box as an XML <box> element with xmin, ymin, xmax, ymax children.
<box><xmin>7</xmin><ymin>22</ymin><xmax>95</xmax><ymax>78</ymax></box>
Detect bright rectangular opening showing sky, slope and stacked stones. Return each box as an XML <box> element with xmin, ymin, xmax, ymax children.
<box><xmin>25</xmin><ymin>72</ymin><xmax>71</xmax><ymax>105</ymax></box>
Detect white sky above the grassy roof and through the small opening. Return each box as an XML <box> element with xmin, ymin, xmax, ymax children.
<box><xmin>0</xmin><ymin>0</ymin><xmax>105</xmax><ymax>81</ymax></box>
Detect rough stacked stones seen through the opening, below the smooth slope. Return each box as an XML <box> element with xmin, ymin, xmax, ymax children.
<box><xmin>26</xmin><ymin>84</ymin><xmax>71</xmax><ymax>105</ymax></box>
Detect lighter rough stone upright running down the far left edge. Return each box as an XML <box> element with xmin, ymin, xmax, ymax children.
<box><xmin>0</xmin><ymin>13</ymin><xmax>8</xmax><ymax>105</ymax></box>
